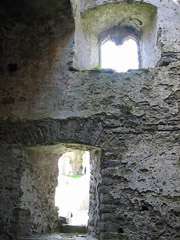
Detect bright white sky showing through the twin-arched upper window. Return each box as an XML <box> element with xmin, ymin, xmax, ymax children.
<box><xmin>101</xmin><ymin>38</ymin><xmax>139</xmax><ymax>72</ymax></box>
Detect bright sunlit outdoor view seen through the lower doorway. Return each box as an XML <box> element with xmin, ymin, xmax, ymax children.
<box><xmin>55</xmin><ymin>151</ymin><xmax>90</xmax><ymax>225</ymax></box>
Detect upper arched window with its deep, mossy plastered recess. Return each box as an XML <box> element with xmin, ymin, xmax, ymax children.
<box><xmin>73</xmin><ymin>1</ymin><xmax>157</xmax><ymax>71</ymax></box>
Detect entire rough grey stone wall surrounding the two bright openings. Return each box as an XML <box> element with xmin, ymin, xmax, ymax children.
<box><xmin>0</xmin><ymin>0</ymin><xmax>180</xmax><ymax>240</ymax></box>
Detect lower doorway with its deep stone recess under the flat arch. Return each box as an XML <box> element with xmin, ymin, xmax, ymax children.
<box><xmin>18</xmin><ymin>143</ymin><xmax>102</xmax><ymax>236</ymax></box>
